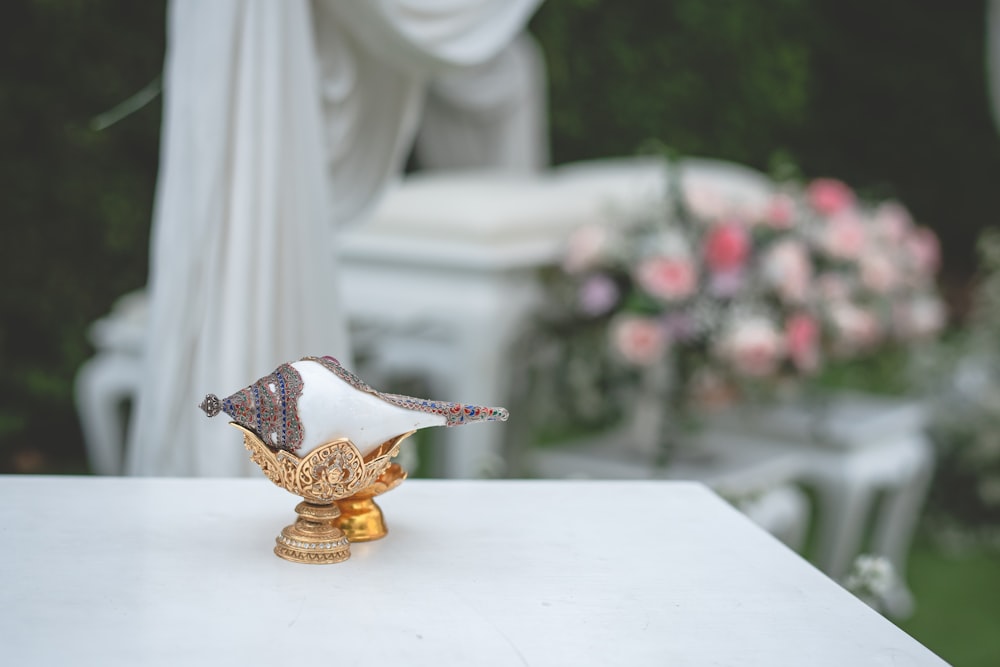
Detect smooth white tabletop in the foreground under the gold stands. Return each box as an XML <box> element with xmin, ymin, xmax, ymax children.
<box><xmin>0</xmin><ymin>477</ymin><xmax>944</xmax><ymax>667</ymax></box>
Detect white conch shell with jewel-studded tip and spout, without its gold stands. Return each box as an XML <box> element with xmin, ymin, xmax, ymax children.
<box><xmin>200</xmin><ymin>357</ymin><xmax>508</xmax><ymax>457</ymax></box>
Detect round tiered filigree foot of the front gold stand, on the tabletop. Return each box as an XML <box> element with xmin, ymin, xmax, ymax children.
<box><xmin>274</xmin><ymin>501</ymin><xmax>351</xmax><ymax>565</ymax></box>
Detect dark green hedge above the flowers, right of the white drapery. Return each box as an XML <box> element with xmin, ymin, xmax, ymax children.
<box><xmin>531</xmin><ymin>0</ymin><xmax>1000</xmax><ymax>276</ymax></box>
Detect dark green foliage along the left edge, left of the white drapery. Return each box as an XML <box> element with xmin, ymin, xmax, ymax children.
<box><xmin>0</xmin><ymin>0</ymin><xmax>164</xmax><ymax>471</ymax></box>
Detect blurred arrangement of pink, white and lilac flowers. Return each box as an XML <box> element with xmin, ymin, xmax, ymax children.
<box><xmin>562</xmin><ymin>160</ymin><xmax>945</xmax><ymax>422</ymax></box>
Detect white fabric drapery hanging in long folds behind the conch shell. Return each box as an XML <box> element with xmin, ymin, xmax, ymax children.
<box><xmin>126</xmin><ymin>0</ymin><xmax>539</xmax><ymax>476</ymax></box>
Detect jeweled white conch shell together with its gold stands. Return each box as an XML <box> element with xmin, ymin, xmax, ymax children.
<box><xmin>200</xmin><ymin>357</ymin><xmax>508</xmax><ymax>563</ymax></box>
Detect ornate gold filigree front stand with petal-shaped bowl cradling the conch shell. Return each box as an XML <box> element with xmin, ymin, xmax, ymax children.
<box><xmin>230</xmin><ymin>422</ymin><xmax>414</xmax><ymax>563</ymax></box>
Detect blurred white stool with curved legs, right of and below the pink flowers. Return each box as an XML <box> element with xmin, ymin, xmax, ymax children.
<box><xmin>721</xmin><ymin>393</ymin><xmax>935</xmax><ymax>617</ymax></box>
